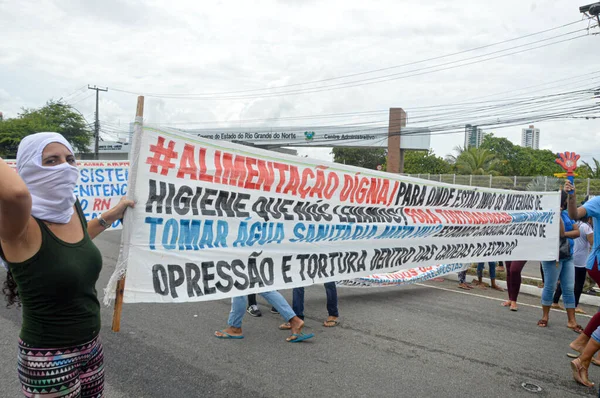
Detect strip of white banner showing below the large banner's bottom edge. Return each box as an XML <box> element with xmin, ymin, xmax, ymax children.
<box><xmin>337</xmin><ymin>263</ymin><xmax>471</xmax><ymax>287</ymax></box>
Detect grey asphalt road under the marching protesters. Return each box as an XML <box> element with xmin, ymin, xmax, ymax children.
<box><xmin>0</xmin><ymin>232</ymin><xmax>600</xmax><ymax>398</ymax></box>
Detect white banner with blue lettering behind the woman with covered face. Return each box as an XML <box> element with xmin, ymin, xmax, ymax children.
<box><xmin>5</xmin><ymin>160</ymin><xmax>129</xmax><ymax>229</ymax></box>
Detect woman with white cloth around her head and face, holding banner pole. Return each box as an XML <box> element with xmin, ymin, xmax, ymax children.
<box><xmin>0</xmin><ymin>133</ymin><xmax>133</xmax><ymax>397</ymax></box>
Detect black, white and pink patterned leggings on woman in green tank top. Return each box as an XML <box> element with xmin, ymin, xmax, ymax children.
<box><xmin>18</xmin><ymin>337</ymin><xmax>104</xmax><ymax>398</ymax></box>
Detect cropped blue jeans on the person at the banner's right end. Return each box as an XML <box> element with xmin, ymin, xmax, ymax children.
<box><xmin>542</xmin><ymin>257</ymin><xmax>575</xmax><ymax>308</ymax></box>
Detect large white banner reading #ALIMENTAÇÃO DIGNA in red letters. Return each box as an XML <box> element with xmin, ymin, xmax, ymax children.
<box><xmin>106</xmin><ymin>126</ymin><xmax>559</xmax><ymax>303</ymax></box>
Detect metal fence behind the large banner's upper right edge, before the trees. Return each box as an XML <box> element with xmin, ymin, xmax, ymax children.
<box><xmin>405</xmin><ymin>174</ymin><xmax>600</xmax><ymax>199</ymax></box>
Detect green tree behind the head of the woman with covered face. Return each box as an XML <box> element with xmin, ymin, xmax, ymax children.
<box><xmin>0</xmin><ymin>101</ymin><xmax>93</xmax><ymax>158</ymax></box>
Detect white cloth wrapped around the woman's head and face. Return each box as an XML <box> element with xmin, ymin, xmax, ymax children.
<box><xmin>17</xmin><ymin>133</ymin><xmax>79</xmax><ymax>224</ymax></box>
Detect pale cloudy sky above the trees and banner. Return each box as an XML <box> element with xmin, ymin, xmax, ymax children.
<box><xmin>0</xmin><ymin>0</ymin><xmax>600</xmax><ymax>163</ymax></box>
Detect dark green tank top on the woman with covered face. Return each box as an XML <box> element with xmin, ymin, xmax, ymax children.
<box><xmin>0</xmin><ymin>201</ymin><xmax>102</xmax><ymax>348</ymax></box>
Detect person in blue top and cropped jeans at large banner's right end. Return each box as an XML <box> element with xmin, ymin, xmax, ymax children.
<box><xmin>538</xmin><ymin>191</ymin><xmax>583</xmax><ymax>333</ymax></box>
